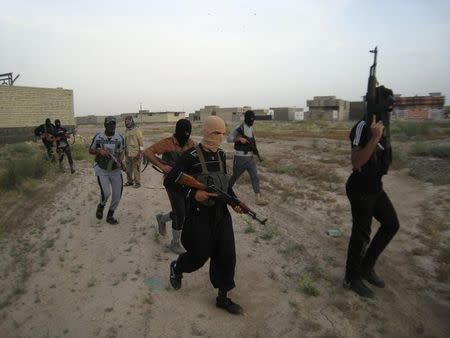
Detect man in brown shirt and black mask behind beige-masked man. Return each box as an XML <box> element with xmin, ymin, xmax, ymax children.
<box><xmin>144</xmin><ymin>119</ymin><xmax>194</xmax><ymax>254</ymax></box>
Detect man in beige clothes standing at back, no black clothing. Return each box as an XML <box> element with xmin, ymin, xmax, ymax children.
<box><xmin>125</xmin><ymin>116</ymin><xmax>144</xmax><ymax>188</ymax></box>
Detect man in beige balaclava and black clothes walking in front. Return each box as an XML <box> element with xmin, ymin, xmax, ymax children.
<box><xmin>164</xmin><ymin>116</ymin><xmax>243</xmax><ymax>314</ymax></box>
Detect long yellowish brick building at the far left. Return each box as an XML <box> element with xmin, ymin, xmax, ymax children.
<box><xmin>0</xmin><ymin>85</ymin><xmax>75</xmax><ymax>143</ymax></box>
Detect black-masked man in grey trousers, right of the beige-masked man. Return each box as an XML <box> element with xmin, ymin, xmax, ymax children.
<box><xmin>227</xmin><ymin>110</ymin><xmax>267</xmax><ymax>205</ymax></box>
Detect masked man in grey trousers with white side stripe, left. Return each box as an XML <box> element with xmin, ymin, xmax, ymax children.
<box><xmin>89</xmin><ymin>117</ymin><xmax>125</xmax><ymax>224</ymax></box>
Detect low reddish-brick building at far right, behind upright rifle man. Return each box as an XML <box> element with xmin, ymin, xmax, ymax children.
<box><xmin>392</xmin><ymin>93</ymin><xmax>445</xmax><ymax>120</ymax></box>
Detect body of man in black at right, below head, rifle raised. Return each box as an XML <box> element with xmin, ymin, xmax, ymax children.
<box><xmin>345</xmin><ymin>112</ymin><xmax>399</xmax><ymax>298</ymax></box>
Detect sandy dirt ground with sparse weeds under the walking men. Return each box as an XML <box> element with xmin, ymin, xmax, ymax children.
<box><xmin>0</xmin><ymin>130</ymin><xmax>450</xmax><ymax>337</ymax></box>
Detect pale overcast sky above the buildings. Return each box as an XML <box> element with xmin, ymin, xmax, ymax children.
<box><xmin>0</xmin><ymin>0</ymin><xmax>450</xmax><ymax>115</ymax></box>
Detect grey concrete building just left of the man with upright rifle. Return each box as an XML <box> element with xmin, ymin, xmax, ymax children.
<box><xmin>305</xmin><ymin>96</ymin><xmax>350</xmax><ymax>121</ymax></box>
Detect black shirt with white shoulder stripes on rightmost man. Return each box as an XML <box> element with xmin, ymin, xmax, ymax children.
<box><xmin>348</xmin><ymin>120</ymin><xmax>389</xmax><ymax>193</ymax></box>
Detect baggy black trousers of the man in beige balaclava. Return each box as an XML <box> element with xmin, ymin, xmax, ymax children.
<box><xmin>177</xmin><ymin>203</ymin><xmax>236</xmax><ymax>291</ymax></box>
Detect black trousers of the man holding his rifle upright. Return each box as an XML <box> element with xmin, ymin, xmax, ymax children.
<box><xmin>345</xmin><ymin>182</ymin><xmax>400</xmax><ymax>282</ymax></box>
